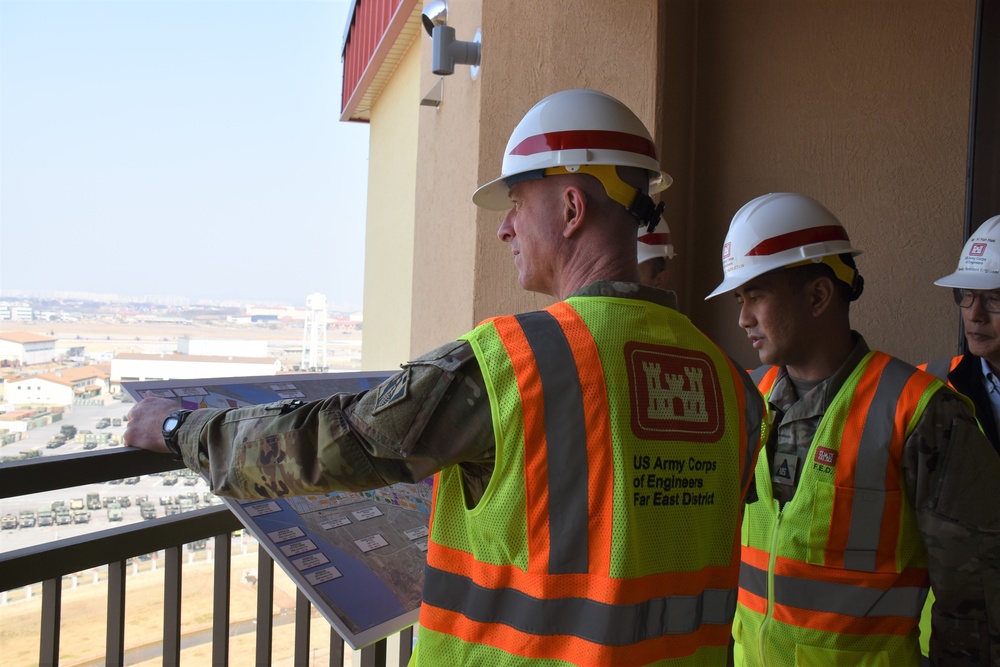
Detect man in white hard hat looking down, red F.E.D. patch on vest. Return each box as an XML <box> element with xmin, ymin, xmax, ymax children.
<box><xmin>709</xmin><ymin>193</ymin><xmax>1000</xmax><ymax>667</ymax></box>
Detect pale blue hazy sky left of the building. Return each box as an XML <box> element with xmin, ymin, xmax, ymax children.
<box><xmin>0</xmin><ymin>0</ymin><xmax>368</xmax><ymax>307</ymax></box>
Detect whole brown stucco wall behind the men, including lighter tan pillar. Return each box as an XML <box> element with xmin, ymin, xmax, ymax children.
<box><xmin>390</xmin><ymin>0</ymin><xmax>975</xmax><ymax>366</ymax></box>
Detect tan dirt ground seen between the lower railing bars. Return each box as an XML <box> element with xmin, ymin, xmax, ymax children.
<box><xmin>0</xmin><ymin>552</ymin><xmax>364</xmax><ymax>667</ymax></box>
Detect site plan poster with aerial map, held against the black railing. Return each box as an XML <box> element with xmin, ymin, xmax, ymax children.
<box><xmin>121</xmin><ymin>372</ymin><xmax>432</xmax><ymax>649</ymax></box>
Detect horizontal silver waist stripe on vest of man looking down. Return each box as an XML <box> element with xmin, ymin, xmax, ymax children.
<box><xmin>740</xmin><ymin>563</ymin><xmax>928</xmax><ymax>618</ymax></box>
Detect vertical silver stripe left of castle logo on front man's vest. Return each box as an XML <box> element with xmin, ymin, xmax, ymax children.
<box><xmin>516</xmin><ymin>311</ymin><xmax>590</xmax><ymax>574</ymax></box>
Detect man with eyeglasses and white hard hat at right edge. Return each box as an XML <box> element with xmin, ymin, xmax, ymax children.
<box><xmin>926</xmin><ymin>215</ymin><xmax>1000</xmax><ymax>454</ymax></box>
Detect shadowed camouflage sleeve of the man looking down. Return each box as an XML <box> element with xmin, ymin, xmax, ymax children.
<box><xmin>903</xmin><ymin>390</ymin><xmax>1000</xmax><ymax>665</ymax></box>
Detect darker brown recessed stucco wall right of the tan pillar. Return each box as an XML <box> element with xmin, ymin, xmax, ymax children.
<box><xmin>675</xmin><ymin>0</ymin><xmax>978</xmax><ymax>365</ymax></box>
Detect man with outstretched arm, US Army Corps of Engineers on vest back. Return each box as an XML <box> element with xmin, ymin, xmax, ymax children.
<box><xmin>125</xmin><ymin>90</ymin><xmax>764</xmax><ymax>667</ymax></box>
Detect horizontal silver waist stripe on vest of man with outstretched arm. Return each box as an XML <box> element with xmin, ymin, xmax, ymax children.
<box><xmin>424</xmin><ymin>566</ymin><xmax>736</xmax><ymax>646</ymax></box>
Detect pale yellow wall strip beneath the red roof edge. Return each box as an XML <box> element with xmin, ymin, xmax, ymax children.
<box><xmin>361</xmin><ymin>40</ymin><xmax>421</xmax><ymax>370</ymax></box>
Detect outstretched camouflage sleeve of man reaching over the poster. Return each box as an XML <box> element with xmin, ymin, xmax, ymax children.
<box><xmin>178</xmin><ymin>342</ymin><xmax>495</xmax><ymax>498</ymax></box>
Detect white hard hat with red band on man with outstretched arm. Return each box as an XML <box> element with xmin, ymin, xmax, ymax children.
<box><xmin>472</xmin><ymin>89</ymin><xmax>673</xmax><ymax>215</ymax></box>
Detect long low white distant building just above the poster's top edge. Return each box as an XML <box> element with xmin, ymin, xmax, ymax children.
<box><xmin>111</xmin><ymin>354</ymin><xmax>281</xmax><ymax>391</ymax></box>
